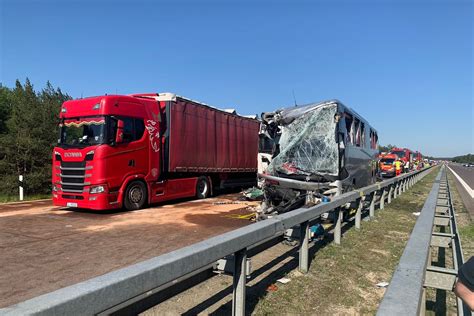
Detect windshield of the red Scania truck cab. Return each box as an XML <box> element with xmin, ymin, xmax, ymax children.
<box><xmin>59</xmin><ymin>116</ymin><xmax>106</xmax><ymax>147</ymax></box>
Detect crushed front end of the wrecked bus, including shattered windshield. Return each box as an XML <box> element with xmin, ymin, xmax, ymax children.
<box><xmin>257</xmin><ymin>101</ymin><xmax>344</xmax><ymax>219</ymax></box>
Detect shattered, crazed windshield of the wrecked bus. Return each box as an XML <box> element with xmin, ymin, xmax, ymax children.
<box><xmin>268</xmin><ymin>104</ymin><xmax>339</xmax><ymax>176</ymax></box>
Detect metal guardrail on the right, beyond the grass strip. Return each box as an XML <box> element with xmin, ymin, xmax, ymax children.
<box><xmin>377</xmin><ymin>166</ymin><xmax>471</xmax><ymax>316</ymax></box>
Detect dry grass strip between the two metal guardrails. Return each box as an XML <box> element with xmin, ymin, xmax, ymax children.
<box><xmin>254</xmin><ymin>168</ymin><xmax>439</xmax><ymax>315</ymax></box>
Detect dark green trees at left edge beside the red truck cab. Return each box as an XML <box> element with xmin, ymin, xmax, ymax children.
<box><xmin>0</xmin><ymin>79</ymin><xmax>71</xmax><ymax>196</ymax></box>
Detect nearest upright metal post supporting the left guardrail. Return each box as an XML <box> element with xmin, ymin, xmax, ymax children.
<box><xmin>232</xmin><ymin>249</ymin><xmax>247</xmax><ymax>316</ymax></box>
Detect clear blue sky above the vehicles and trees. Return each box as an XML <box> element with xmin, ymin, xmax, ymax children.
<box><xmin>0</xmin><ymin>0</ymin><xmax>474</xmax><ymax>156</ymax></box>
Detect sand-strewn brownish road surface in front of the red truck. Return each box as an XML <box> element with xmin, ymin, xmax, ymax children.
<box><xmin>0</xmin><ymin>194</ymin><xmax>257</xmax><ymax>307</ymax></box>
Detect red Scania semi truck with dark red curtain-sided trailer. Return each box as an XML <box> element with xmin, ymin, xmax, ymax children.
<box><xmin>52</xmin><ymin>93</ymin><xmax>259</xmax><ymax>210</ymax></box>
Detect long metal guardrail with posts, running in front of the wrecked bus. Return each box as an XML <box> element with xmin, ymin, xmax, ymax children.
<box><xmin>0</xmin><ymin>169</ymin><xmax>431</xmax><ymax>315</ymax></box>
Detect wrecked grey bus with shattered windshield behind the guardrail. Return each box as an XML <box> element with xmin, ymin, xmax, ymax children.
<box><xmin>258</xmin><ymin>100</ymin><xmax>378</xmax><ymax>218</ymax></box>
